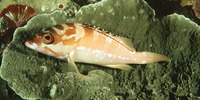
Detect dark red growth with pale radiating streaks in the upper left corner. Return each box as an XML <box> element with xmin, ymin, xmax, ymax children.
<box><xmin>0</xmin><ymin>4</ymin><xmax>37</xmax><ymax>63</ymax></box>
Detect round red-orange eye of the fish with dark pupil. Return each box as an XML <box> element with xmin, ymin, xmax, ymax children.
<box><xmin>42</xmin><ymin>33</ymin><xmax>54</xmax><ymax>44</ymax></box>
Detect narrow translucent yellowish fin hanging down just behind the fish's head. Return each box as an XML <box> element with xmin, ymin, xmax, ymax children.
<box><xmin>67</xmin><ymin>53</ymin><xmax>85</xmax><ymax>78</ymax></box>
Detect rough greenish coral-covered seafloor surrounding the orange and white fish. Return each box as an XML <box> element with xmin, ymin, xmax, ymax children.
<box><xmin>0</xmin><ymin>0</ymin><xmax>200</xmax><ymax>100</ymax></box>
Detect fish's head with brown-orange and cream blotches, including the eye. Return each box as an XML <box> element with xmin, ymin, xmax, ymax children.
<box><xmin>25</xmin><ymin>24</ymin><xmax>82</xmax><ymax>59</ymax></box>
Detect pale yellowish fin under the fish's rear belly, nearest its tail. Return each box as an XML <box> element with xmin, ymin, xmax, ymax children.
<box><xmin>102</xmin><ymin>64</ymin><xmax>132</xmax><ymax>70</ymax></box>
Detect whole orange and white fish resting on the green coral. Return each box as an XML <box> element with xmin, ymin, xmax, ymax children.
<box><xmin>25</xmin><ymin>23</ymin><xmax>170</xmax><ymax>77</ymax></box>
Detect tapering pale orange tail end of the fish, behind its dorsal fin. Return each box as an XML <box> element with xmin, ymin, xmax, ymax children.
<box><xmin>133</xmin><ymin>52</ymin><xmax>170</xmax><ymax>64</ymax></box>
